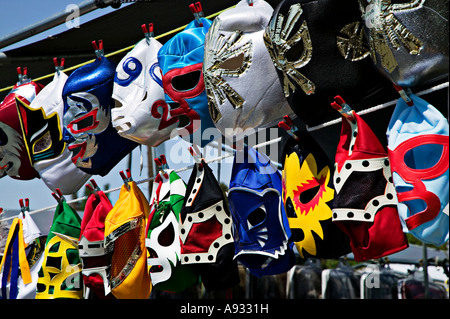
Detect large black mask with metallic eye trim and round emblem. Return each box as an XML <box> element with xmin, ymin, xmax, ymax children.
<box><xmin>264</xmin><ymin>0</ymin><xmax>392</xmax><ymax>126</ymax></box>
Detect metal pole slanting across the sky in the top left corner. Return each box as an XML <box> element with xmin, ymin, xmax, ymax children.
<box><xmin>0</xmin><ymin>0</ymin><xmax>113</xmax><ymax>48</ymax></box>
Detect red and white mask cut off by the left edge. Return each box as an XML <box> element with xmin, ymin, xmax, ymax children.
<box><xmin>0</xmin><ymin>80</ymin><xmax>43</xmax><ymax>180</ymax></box>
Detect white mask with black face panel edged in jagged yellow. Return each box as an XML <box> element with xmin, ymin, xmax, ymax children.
<box><xmin>16</xmin><ymin>72</ymin><xmax>90</xmax><ymax>194</ymax></box>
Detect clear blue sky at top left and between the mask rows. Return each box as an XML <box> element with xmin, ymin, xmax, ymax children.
<box><xmin>0</xmin><ymin>0</ymin><xmax>231</xmax><ymax>215</ymax></box>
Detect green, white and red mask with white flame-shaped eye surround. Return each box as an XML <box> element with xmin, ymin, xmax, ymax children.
<box><xmin>145</xmin><ymin>170</ymin><xmax>199</xmax><ymax>292</ymax></box>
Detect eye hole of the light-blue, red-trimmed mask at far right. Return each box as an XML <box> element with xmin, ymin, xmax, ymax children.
<box><xmin>404</xmin><ymin>144</ymin><xmax>444</xmax><ymax>169</ymax></box>
